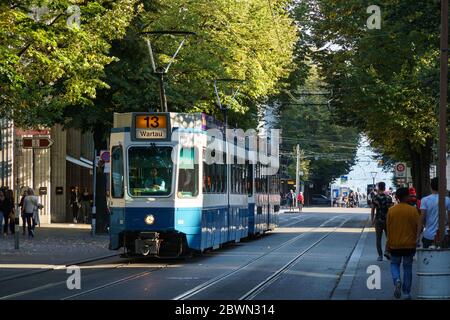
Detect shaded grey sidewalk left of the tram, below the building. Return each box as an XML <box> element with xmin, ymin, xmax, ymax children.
<box><xmin>0</xmin><ymin>224</ymin><xmax>112</xmax><ymax>281</ymax></box>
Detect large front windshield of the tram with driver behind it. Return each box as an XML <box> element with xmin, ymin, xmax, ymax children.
<box><xmin>128</xmin><ymin>146</ymin><xmax>173</xmax><ymax>197</ymax></box>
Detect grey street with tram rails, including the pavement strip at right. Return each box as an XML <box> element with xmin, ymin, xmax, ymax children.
<box><xmin>0</xmin><ymin>208</ymin><xmax>414</xmax><ymax>300</ymax></box>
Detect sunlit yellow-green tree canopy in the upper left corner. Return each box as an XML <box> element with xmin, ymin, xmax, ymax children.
<box><xmin>0</xmin><ymin>0</ymin><xmax>137</xmax><ymax>126</ymax></box>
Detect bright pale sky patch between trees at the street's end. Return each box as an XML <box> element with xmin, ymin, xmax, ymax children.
<box><xmin>333</xmin><ymin>137</ymin><xmax>393</xmax><ymax>192</ymax></box>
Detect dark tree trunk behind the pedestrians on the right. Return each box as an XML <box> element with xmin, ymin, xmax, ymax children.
<box><xmin>409</xmin><ymin>140</ymin><xmax>433</xmax><ymax>198</ymax></box>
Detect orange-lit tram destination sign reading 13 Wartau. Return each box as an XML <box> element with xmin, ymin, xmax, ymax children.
<box><xmin>132</xmin><ymin>112</ymin><xmax>171</xmax><ymax>141</ymax></box>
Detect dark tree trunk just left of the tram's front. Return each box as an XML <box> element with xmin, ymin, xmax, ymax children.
<box><xmin>94</xmin><ymin>124</ymin><xmax>109</xmax><ymax>234</ymax></box>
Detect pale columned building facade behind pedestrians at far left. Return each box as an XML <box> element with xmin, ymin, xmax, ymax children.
<box><xmin>0</xmin><ymin>119</ymin><xmax>94</xmax><ymax>223</ymax></box>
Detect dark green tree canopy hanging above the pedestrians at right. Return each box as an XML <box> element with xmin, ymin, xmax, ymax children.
<box><xmin>308</xmin><ymin>0</ymin><xmax>446</xmax><ymax>195</ymax></box>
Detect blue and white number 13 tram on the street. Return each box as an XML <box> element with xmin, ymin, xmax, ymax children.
<box><xmin>108</xmin><ymin>113</ymin><xmax>280</xmax><ymax>256</ymax></box>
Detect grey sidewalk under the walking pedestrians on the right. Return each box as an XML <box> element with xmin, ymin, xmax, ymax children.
<box><xmin>332</xmin><ymin>219</ymin><xmax>418</xmax><ymax>300</ymax></box>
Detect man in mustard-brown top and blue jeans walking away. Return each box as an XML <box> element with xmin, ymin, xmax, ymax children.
<box><xmin>386</xmin><ymin>188</ymin><xmax>420</xmax><ymax>300</ymax></box>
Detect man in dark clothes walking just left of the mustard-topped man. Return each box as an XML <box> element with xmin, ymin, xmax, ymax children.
<box><xmin>370</xmin><ymin>182</ymin><xmax>393</xmax><ymax>261</ymax></box>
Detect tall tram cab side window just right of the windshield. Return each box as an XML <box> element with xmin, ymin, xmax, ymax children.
<box><xmin>178</xmin><ymin>148</ymin><xmax>198</xmax><ymax>198</ymax></box>
